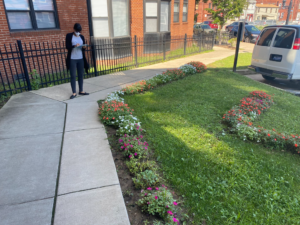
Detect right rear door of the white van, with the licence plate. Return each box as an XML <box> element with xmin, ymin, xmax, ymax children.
<box><xmin>268</xmin><ymin>27</ymin><xmax>298</xmax><ymax>74</ymax></box>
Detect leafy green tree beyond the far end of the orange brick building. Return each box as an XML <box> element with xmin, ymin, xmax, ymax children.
<box><xmin>206</xmin><ymin>0</ymin><xmax>247</xmax><ymax>29</ymax></box>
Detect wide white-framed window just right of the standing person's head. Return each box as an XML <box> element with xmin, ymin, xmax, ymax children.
<box><xmin>91</xmin><ymin>0</ymin><xmax>129</xmax><ymax>37</ymax></box>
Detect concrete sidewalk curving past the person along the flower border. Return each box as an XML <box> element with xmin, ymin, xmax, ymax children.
<box><xmin>0</xmin><ymin>44</ymin><xmax>253</xmax><ymax>225</ymax></box>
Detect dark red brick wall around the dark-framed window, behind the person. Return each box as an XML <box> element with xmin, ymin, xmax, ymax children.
<box><xmin>0</xmin><ymin>0</ymin><xmax>89</xmax><ymax>44</ymax></box>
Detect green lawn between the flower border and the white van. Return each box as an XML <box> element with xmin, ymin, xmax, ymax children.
<box><xmin>125</xmin><ymin>54</ymin><xmax>300</xmax><ymax>225</ymax></box>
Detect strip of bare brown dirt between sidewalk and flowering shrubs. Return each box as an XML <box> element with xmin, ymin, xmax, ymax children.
<box><xmin>105</xmin><ymin>126</ymin><xmax>191</xmax><ymax>225</ymax></box>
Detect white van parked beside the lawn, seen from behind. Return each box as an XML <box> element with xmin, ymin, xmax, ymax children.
<box><xmin>249</xmin><ymin>25</ymin><xmax>300</xmax><ymax>80</ymax></box>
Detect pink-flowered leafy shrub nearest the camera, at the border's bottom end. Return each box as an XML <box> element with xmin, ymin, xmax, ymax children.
<box><xmin>137</xmin><ymin>185</ymin><xmax>177</xmax><ymax>222</ymax></box>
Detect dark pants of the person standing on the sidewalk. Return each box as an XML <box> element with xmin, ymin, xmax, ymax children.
<box><xmin>70</xmin><ymin>59</ymin><xmax>84</xmax><ymax>93</ymax></box>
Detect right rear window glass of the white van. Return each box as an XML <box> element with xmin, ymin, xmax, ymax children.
<box><xmin>273</xmin><ymin>28</ymin><xmax>295</xmax><ymax>49</ymax></box>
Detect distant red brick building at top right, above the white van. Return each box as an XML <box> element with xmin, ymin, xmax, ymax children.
<box><xmin>256</xmin><ymin>0</ymin><xmax>300</xmax><ymax>22</ymax></box>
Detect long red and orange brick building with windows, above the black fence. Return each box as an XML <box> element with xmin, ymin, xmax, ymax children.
<box><xmin>0</xmin><ymin>0</ymin><xmax>195</xmax><ymax>44</ymax></box>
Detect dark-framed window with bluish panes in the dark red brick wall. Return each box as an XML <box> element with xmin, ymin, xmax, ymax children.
<box><xmin>4</xmin><ymin>0</ymin><xmax>58</xmax><ymax>31</ymax></box>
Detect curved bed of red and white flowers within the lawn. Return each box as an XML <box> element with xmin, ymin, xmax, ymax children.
<box><xmin>223</xmin><ymin>91</ymin><xmax>300</xmax><ymax>154</ymax></box>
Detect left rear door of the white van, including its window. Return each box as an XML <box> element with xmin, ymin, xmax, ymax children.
<box><xmin>251</xmin><ymin>27</ymin><xmax>277</xmax><ymax>69</ymax></box>
